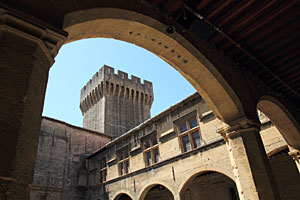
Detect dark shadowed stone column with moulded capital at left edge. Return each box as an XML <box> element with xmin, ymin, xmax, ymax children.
<box><xmin>0</xmin><ymin>5</ymin><xmax>66</xmax><ymax>200</ymax></box>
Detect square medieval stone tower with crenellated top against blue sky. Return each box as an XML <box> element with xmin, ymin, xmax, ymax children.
<box><xmin>80</xmin><ymin>65</ymin><xmax>153</xmax><ymax>137</ymax></box>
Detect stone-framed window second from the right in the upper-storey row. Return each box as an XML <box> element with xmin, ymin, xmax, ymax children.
<box><xmin>142</xmin><ymin>132</ymin><xmax>159</xmax><ymax>166</ymax></box>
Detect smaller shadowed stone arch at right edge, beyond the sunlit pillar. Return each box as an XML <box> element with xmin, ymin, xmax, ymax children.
<box><xmin>257</xmin><ymin>96</ymin><xmax>300</xmax><ymax>149</ymax></box>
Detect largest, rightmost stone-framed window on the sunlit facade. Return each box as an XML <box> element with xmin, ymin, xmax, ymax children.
<box><xmin>177</xmin><ymin>115</ymin><xmax>201</xmax><ymax>152</ymax></box>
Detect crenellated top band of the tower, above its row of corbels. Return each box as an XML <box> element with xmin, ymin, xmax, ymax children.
<box><xmin>80</xmin><ymin>65</ymin><xmax>153</xmax><ymax>100</ymax></box>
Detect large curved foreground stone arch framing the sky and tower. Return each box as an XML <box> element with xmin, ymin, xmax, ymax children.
<box><xmin>64</xmin><ymin>8</ymin><xmax>247</xmax><ymax>123</ymax></box>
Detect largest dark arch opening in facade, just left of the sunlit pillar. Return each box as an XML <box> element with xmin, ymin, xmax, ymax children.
<box><xmin>180</xmin><ymin>171</ymin><xmax>239</xmax><ymax>200</ymax></box>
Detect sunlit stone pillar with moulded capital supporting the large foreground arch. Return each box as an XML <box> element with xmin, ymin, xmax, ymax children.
<box><xmin>219</xmin><ymin>119</ymin><xmax>280</xmax><ymax>200</ymax></box>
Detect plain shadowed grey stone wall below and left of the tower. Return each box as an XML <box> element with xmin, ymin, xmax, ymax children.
<box><xmin>31</xmin><ymin>117</ymin><xmax>111</xmax><ymax>200</ymax></box>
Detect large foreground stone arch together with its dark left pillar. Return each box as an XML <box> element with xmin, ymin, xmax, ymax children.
<box><xmin>0</xmin><ymin>5</ymin><xmax>278</xmax><ymax>199</ymax></box>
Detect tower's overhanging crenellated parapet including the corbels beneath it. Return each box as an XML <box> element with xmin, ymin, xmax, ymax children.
<box><xmin>80</xmin><ymin>65</ymin><xmax>154</xmax><ymax>115</ymax></box>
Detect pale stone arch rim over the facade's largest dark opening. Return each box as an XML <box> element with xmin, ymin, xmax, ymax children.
<box><xmin>178</xmin><ymin>167</ymin><xmax>235</xmax><ymax>195</ymax></box>
